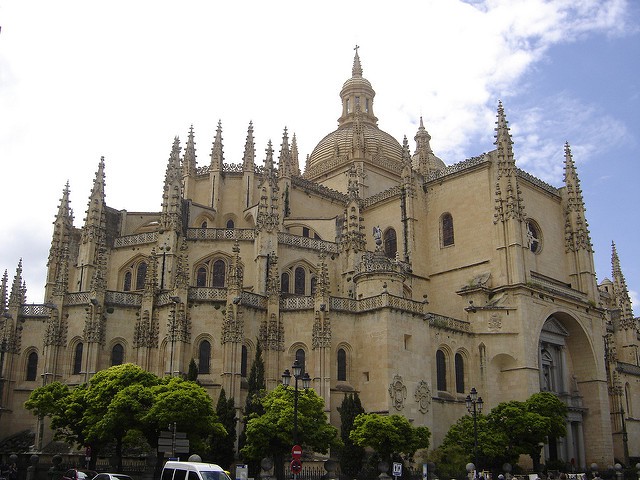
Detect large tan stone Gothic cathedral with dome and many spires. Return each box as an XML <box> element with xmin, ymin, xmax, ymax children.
<box><xmin>0</xmin><ymin>49</ymin><xmax>640</xmax><ymax>469</ymax></box>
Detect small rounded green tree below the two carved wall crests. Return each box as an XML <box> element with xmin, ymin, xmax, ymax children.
<box><xmin>349</xmin><ymin>413</ymin><xmax>431</xmax><ymax>462</ymax></box>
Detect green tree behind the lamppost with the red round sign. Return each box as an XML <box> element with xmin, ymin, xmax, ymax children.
<box><xmin>242</xmin><ymin>385</ymin><xmax>341</xmax><ymax>478</ymax></box>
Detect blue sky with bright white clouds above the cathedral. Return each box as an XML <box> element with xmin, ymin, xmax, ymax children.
<box><xmin>0</xmin><ymin>0</ymin><xmax>640</xmax><ymax>313</ymax></box>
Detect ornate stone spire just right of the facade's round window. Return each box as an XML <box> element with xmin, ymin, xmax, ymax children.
<box><xmin>564</xmin><ymin>142</ymin><xmax>593</xmax><ymax>252</ymax></box>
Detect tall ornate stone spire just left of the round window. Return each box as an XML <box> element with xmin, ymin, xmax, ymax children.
<box><xmin>494</xmin><ymin>101</ymin><xmax>525</xmax><ymax>223</ymax></box>
